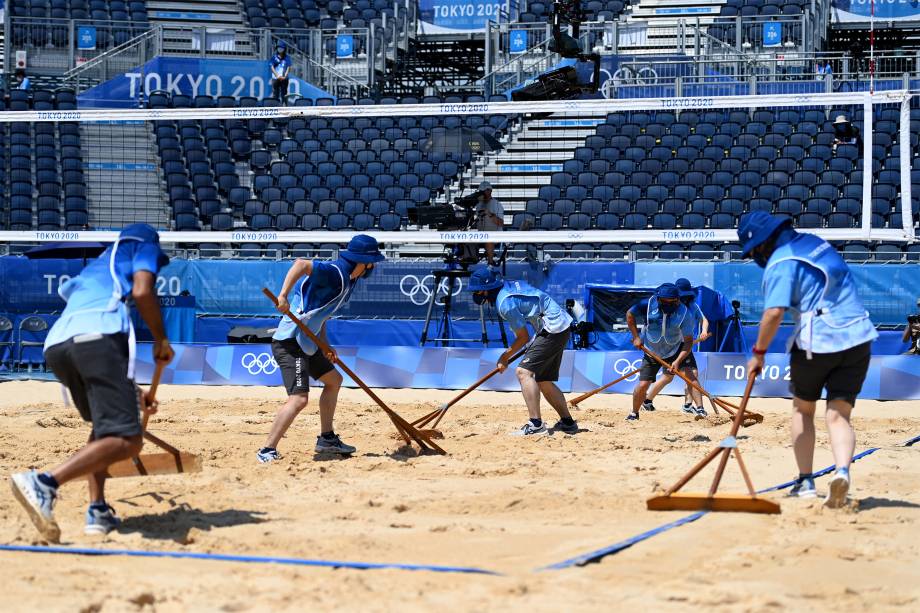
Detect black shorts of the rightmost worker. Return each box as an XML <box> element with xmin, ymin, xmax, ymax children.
<box><xmin>789</xmin><ymin>343</ymin><xmax>872</xmax><ymax>405</ymax></box>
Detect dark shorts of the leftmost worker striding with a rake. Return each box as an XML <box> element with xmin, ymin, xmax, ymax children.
<box><xmin>45</xmin><ymin>334</ymin><xmax>141</xmax><ymax>439</ymax></box>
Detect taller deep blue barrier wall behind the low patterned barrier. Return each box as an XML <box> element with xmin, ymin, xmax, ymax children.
<box><xmin>0</xmin><ymin>256</ymin><xmax>920</xmax><ymax>325</ymax></box>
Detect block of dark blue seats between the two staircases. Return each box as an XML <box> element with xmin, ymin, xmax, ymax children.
<box><xmin>150</xmin><ymin>93</ymin><xmax>508</xmax><ymax>237</ymax></box>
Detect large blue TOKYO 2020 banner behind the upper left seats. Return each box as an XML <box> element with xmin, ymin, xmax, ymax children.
<box><xmin>78</xmin><ymin>57</ymin><xmax>332</xmax><ymax>108</ymax></box>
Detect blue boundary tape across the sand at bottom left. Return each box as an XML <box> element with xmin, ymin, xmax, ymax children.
<box><xmin>0</xmin><ymin>545</ymin><xmax>501</xmax><ymax>575</ymax></box>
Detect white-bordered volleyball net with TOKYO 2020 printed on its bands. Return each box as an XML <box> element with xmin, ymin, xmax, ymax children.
<box><xmin>0</xmin><ymin>91</ymin><xmax>920</xmax><ymax>254</ymax></box>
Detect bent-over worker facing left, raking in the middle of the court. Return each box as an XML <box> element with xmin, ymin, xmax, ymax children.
<box><xmin>470</xmin><ymin>267</ymin><xmax>578</xmax><ymax>436</ymax></box>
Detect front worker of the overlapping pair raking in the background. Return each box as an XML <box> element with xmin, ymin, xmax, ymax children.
<box><xmin>626</xmin><ymin>283</ymin><xmax>702</xmax><ymax>421</ymax></box>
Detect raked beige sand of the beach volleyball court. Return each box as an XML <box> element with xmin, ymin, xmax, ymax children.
<box><xmin>0</xmin><ymin>382</ymin><xmax>920</xmax><ymax>611</ymax></box>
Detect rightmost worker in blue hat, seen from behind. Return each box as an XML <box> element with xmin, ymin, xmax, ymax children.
<box><xmin>738</xmin><ymin>211</ymin><xmax>878</xmax><ymax>508</ymax></box>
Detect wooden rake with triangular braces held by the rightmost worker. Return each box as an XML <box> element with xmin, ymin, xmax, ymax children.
<box><xmin>646</xmin><ymin>373</ymin><xmax>780</xmax><ymax>513</ymax></box>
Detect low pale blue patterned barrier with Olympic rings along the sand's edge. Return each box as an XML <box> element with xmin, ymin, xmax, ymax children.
<box><xmin>137</xmin><ymin>344</ymin><xmax>920</xmax><ymax>400</ymax></box>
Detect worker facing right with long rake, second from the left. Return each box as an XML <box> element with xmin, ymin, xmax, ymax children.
<box><xmin>256</xmin><ymin>234</ymin><xmax>384</xmax><ymax>464</ymax></box>
